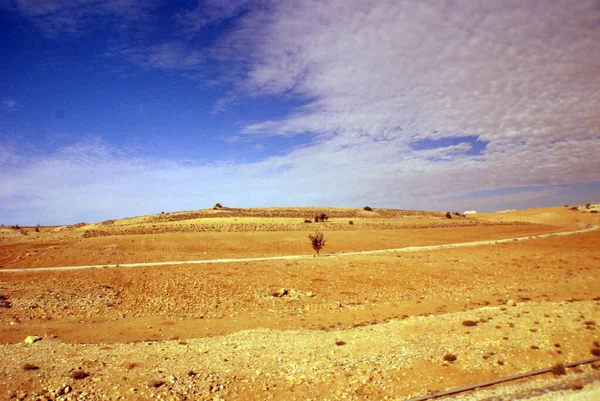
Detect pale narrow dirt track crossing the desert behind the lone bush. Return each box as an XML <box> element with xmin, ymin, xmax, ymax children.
<box><xmin>0</xmin><ymin>225</ymin><xmax>598</xmax><ymax>273</ymax></box>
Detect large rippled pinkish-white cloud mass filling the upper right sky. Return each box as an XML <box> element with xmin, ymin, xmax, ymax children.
<box><xmin>219</xmin><ymin>0</ymin><xmax>600</xmax><ymax>198</ymax></box>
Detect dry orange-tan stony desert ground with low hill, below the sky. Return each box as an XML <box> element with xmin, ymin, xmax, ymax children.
<box><xmin>0</xmin><ymin>205</ymin><xmax>600</xmax><ymax>400</ymax></box>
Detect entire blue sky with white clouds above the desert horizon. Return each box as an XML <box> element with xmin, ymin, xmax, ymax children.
<box><xmin>0</xmin><ymin>0</ymin><xmax>600</xmax><ymax>225</ymax></box>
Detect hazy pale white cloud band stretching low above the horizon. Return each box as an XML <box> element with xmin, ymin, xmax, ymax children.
<box><xmin>0</xmin><ymin>133</ymin><xmax>596</xmax><ymax>224</ymax></box>
